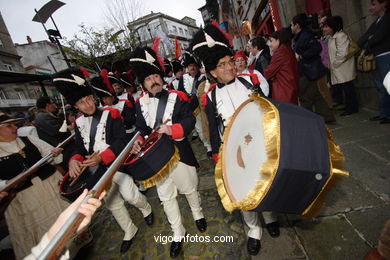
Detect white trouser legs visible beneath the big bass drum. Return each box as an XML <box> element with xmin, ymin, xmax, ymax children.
<box><xmin>241</xmin><ymin>210</ymin><xmax>278</xmax><ymax>240</ymax></box>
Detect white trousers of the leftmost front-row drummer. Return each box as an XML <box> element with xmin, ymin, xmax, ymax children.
<box><xmin>104</xmin><ymin>172</ymin><xmax>152</xmax><ymax>240</ymax></box>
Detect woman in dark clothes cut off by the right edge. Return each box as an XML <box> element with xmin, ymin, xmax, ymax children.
<box><xmin>358</xmin><ymin>0</ymin><xmax>390</xmax><ymax>124</ymax></box>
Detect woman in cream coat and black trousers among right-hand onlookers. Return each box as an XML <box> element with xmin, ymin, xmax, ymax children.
<box><xmin>322</xmin><ymin>16</ymin><xmax>359</xmax><ymax>116</ymax></box>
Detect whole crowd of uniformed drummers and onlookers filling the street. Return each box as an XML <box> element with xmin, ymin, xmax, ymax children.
<box><xmin>0</xmin><ymin>0</ymin><xmax>390</xmax><ymax>259</ymax></box>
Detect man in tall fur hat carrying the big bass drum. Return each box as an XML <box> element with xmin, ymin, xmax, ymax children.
<box><xmin>190</xmin><ymin>25</ymin><xmax>279</xmax><ymax>255</ymax></box>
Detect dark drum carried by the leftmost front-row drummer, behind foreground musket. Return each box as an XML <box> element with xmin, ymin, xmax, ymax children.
<box><xmin>60</xmin><ymin>165</ymin><xmax>107</xmax><ymax>202</ymax></box>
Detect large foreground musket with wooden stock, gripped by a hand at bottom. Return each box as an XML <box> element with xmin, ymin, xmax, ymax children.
<box><xmin>37</xmin><ymin>131</ymin><xmax>140</xmax><ymax>260</ymax></box>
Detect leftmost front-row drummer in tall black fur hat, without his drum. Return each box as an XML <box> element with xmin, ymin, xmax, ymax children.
<box><xmin>53</xmin><ymin>68</ymin><xmax>153</xmax><ymax>253</ymax></box>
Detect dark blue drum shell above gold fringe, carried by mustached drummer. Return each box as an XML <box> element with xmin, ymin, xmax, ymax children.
<box><xmin>124</xmin><ymin>135</ymin><xmax>175</xmax><ymax>181</ymax></box>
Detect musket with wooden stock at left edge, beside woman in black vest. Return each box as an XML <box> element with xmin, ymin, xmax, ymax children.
<box><xmin>0</xmin><ymin>134</ymin><xmax>75</xmax><ymax>215</ymax></box>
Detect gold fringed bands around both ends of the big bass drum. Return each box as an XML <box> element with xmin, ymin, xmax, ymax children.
<box><xmin>215</xmin><ymin>94</ymin><xmax>349</xmax><ymax>217</ymax></box>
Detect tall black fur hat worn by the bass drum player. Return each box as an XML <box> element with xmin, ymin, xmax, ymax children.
<box><xmin>190</xmin><ymin>24</ymin><xmax>233</xmax><ymax>72</ymax></box>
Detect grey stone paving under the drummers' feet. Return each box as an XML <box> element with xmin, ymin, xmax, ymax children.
<box><xmin>77</xmin><ymin>110</ymin><xmax>390</xmax><ymax>260</ymax></box>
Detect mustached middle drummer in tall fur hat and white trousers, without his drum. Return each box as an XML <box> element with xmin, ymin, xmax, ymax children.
<box><xmin>130</xmin><ymin>47</ymin><xmax>207</xmax><ymax>258</ymax></box>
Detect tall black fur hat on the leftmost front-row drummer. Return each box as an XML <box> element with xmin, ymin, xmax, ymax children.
<box><xmin>52</xmin><ymin>67</ymin><xmax>93</xmax><ymax>106</ymax></box>
